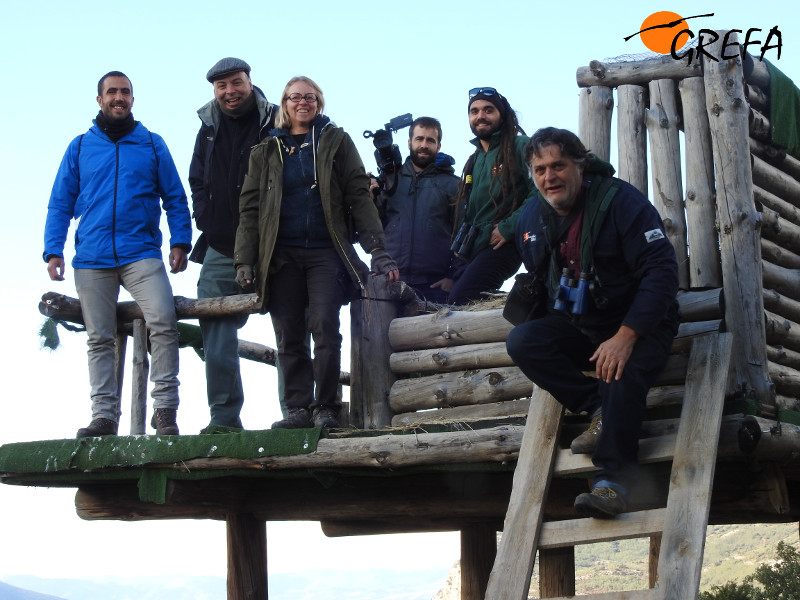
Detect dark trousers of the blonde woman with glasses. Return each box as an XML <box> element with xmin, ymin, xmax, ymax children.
<box><xmin>267</xmin><ymin>246</ymin><xmax>350</xmax><ymax>410</ymax></box>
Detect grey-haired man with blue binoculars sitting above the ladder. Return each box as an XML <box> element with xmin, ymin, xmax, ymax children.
<box><xmin>506</xmin><ymin>127</ymin><xmax>678</xmax><ymax>518</ymax></box>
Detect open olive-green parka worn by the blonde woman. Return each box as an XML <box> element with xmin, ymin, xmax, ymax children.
<box><xmin>233</xmin><ymin>122</ymin><xmax>385</xmax><ymax>313</ymax></box>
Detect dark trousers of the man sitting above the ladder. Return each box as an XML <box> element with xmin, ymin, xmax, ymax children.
<box><xmin>506</xmin><ymin>314</ymin><xmax>678</xmax><ymax>485</ymax></box>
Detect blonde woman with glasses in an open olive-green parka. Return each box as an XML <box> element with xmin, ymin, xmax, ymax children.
<box><xmin>234</xmin><ymin>76</ymin><xmax>399</xmax><ymax>429</ymax></box>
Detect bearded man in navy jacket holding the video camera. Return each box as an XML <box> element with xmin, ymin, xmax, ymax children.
<box><xmin>371</xmin><ymin>117</ymin><xmax>459</xmax><ymax>303</ymax></box>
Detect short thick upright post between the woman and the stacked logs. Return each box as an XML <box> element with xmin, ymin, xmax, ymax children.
<box><xmin>350</xmin><ymin>275</ymin><xmax>397</xmax><ymax>429</ymax></box>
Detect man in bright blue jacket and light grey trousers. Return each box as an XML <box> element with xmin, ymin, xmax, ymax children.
<box><xmin>43</xmin><ymin>71</ymin><xmax>192</xmax><ymax>437</ymax></box>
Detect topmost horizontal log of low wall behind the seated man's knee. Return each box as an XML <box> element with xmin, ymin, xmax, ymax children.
<box><xmin>389</xmin><ymin>309</ymin><xmax>513</xmax><ymax>352</ymax></box>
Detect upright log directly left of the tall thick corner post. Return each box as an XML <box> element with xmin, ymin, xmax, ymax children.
<box><xmin>678</xmin><ymin>77</ymin><xmax>722</xmax><ymax>288</ymax></box>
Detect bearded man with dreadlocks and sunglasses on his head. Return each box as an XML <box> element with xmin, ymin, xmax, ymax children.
<box><xmin>448</xmin><ymin>87</ymin><xmax>533</xmax><ymax>304</ymax></box>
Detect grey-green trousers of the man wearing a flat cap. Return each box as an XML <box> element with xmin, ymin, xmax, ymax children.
<box><xmin>197</xmin><ymin>247</ymin><xmax>247</xmax><ymax>427</ymax></box>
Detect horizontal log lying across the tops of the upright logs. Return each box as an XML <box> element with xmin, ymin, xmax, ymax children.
<box><xmin>575</xmin><ymin>56</ymin><xmax>703</xmax><ymax>88</ymax></box>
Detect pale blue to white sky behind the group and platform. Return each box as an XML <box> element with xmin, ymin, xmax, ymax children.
<box><xmin>0</xmin><ymin>0</ymin><xmax>800</xmax><ymax>592</ymax></box>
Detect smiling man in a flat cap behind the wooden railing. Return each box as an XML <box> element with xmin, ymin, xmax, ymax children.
<box><xmin>189</xmin><ymin>57</ymin><xmax>277</xmax><ymax>432</ymax></box>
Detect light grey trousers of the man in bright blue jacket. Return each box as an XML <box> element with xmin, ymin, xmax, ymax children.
<box><xmin>75</xmin><ymin>258</ymin><xmax>179</xmax><ymax>422</ymax></box>
